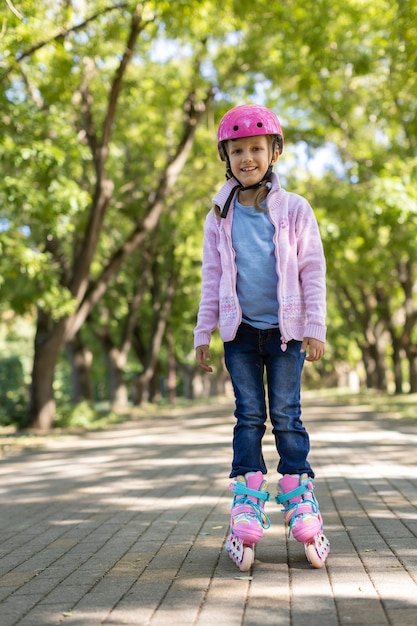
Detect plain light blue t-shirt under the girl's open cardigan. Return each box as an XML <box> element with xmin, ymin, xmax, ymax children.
<box><xmin>232</xmin><ymin>201</ymin><xmax>278</xmax><ymax>329</ymax></box>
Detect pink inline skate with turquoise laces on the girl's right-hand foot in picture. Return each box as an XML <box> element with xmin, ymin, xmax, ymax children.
<box><xmin>275</xmin><ymin>474</ymin><xmax>330</xmax><ymax>568</ymax></box>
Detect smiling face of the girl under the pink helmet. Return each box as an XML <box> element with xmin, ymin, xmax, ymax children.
<box><xmin>226</xmin><ymin>135</ymin><xmax>279</xmax><ymax>187</ymax></box>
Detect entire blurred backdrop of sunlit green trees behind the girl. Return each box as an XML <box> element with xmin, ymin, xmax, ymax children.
<box><xmin>0</xmin><ymin>0</ymin><xmax>417</xmax><ymax>431</ymax></box>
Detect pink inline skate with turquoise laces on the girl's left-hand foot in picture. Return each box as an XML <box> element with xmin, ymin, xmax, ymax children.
<box><xmin>226</xmin><ymin>472</ymin><xmax>271</xmax><ymax>572</ymax></box>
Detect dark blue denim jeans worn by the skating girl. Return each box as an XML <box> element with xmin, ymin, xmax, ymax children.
<box><xmin>224</xmin><ymin>324</ymin><xmax>314</xmax><ymax>478</ymax></box>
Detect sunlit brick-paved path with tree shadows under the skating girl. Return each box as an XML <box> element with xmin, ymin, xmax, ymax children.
<box><xmin>0</xmin><ymin>399</ymin><xmax>417</xmax><ymax>626</ymax></box>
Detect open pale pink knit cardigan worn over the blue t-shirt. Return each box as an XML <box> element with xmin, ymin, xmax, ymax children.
<box><xmin>194</xmin><ymin>174</ymin><xmax>326</xmax><ymax>347</ymax></box>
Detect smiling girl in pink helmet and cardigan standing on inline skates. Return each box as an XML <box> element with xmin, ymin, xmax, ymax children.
<box><xmin>194</xmin><ymin>105</ymin><xmax>329</xmax><ymax>571</ymax></box>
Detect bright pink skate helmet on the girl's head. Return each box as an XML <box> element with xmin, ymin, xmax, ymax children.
<box><xmin>217</xmin><ymin>104</ymin><xmax>284</xmax><ymax>159</ymax></box>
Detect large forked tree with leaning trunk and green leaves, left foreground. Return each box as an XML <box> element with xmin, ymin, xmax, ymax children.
<box><xmin>2</xmin><ymin>0</ymin><xmax>272</xmax><ymax>429</ymax></box>
